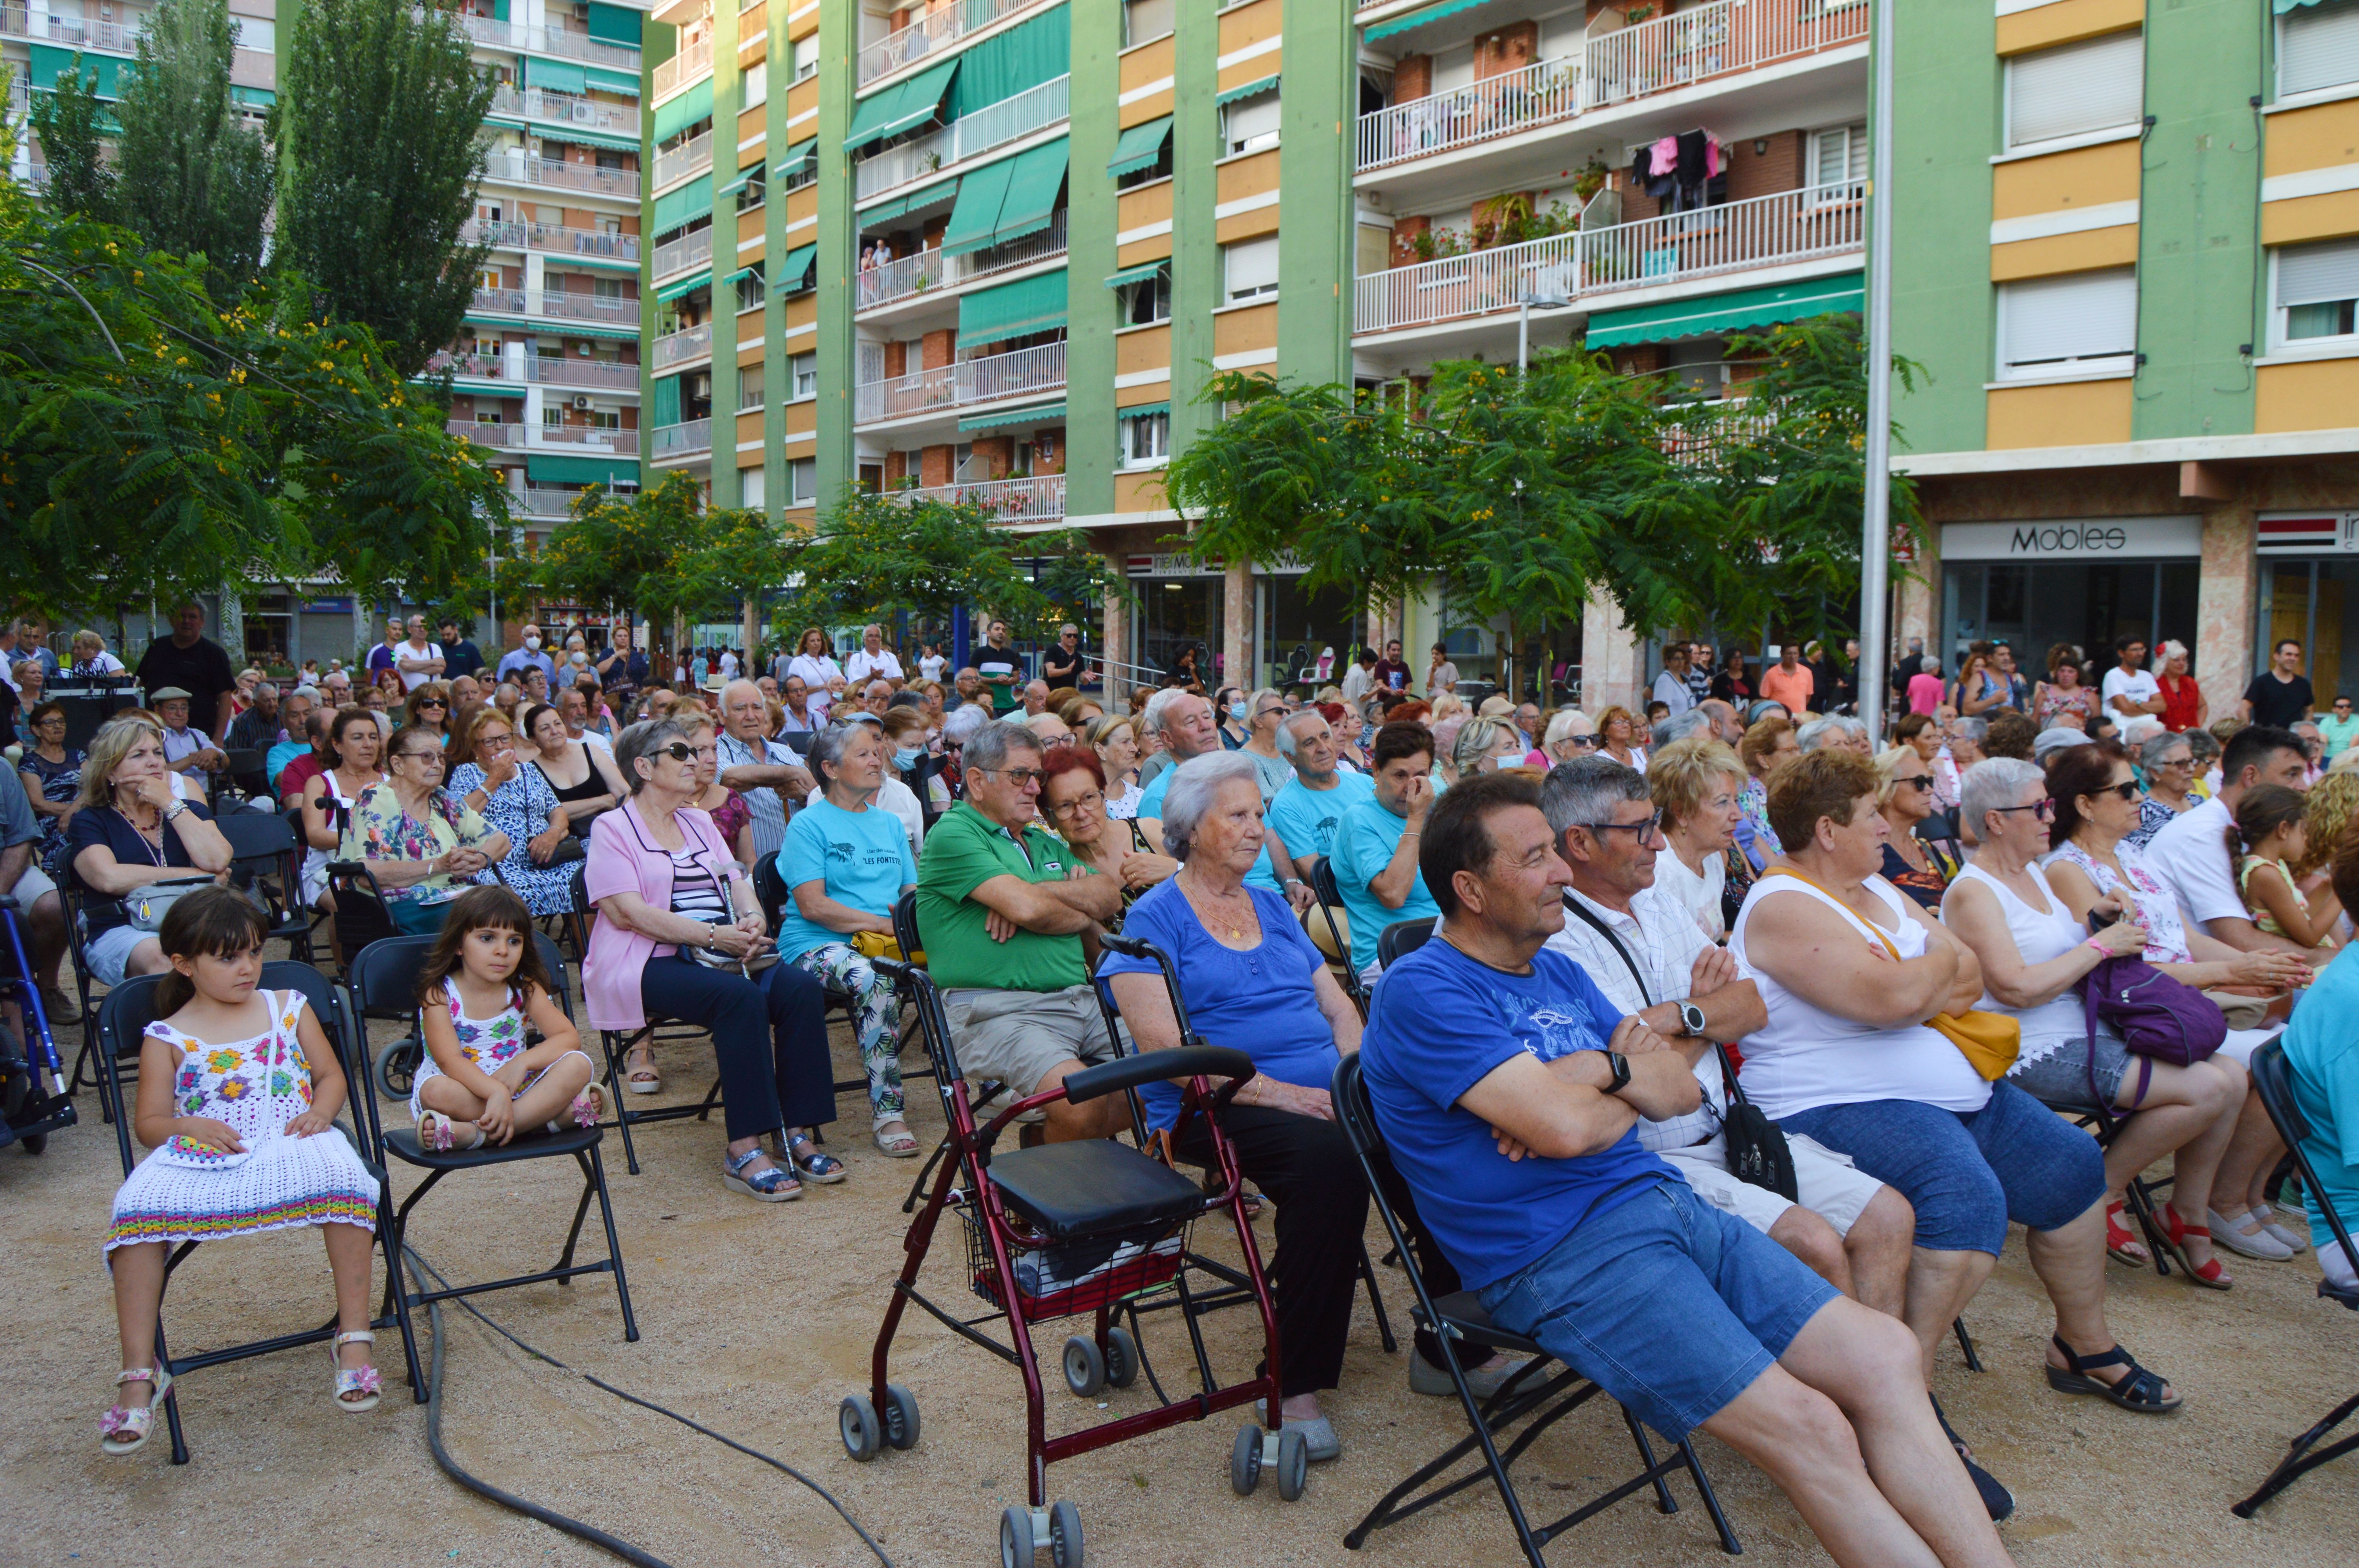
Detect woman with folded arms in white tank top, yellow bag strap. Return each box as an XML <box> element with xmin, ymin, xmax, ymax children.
<box><xmin>1729</xmin><ymin>750</ymin><xmax>2180</xmax><ymax>1415</ymax></box>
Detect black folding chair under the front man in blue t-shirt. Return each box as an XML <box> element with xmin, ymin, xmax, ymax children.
<box><xmin>1330</xmin><ymin>1047</ymin><xmax>1743</xmax><ymax>1568</ymax></box>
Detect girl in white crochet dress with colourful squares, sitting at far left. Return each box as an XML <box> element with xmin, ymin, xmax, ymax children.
<box><xmin>99</xmin><ymin>887</ymin><xmax>378</xmax><ymax>1455</ymax></box>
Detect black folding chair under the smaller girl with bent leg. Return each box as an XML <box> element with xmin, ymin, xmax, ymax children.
<box><xmin>347</xmin><ymin>931</ymin><xmax>639</xmax><ymax>1403</ymax></box>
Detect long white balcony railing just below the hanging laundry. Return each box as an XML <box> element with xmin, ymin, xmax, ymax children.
<box><xmin>1352</xmin><ymin>186</ymin><xmax>1866</xmax><ymax>332</ymax></box>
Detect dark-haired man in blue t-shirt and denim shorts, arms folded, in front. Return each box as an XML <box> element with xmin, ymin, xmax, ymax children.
<box><xmin>1361</xmin><ymin>773</ymin><xmax>2008</xmax><ymax>1566</ymax></box>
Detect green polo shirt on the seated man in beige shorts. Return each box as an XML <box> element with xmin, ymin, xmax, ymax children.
<box><xmin>918</xmin><ymin>802</ymin><xmax>1090</xmax><ymax>990</ymax></box>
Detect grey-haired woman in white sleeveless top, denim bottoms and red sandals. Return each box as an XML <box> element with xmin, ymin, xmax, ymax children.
<box><xmin>1941</xmin><ymin>748</ymin><xmax>2246</xmax><ymax>1290</ymax></box>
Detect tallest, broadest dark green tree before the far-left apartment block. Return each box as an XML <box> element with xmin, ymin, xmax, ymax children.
<box><xmin>274</xmin><ymin>0</ymin><xmax>493</xmax><ymax>375</ymax></box>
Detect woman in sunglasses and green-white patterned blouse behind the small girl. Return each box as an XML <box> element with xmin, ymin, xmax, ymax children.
<box><xmin>340</xmin><ymin>729</ymin><xmax>507</xmax><ymax>936</ymax></box>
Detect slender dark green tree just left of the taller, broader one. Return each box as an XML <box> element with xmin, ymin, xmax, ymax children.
<box><xmin>116</xmin><ymin>0</ymin><xmax>274</xmax><ymax>304</ymax></box>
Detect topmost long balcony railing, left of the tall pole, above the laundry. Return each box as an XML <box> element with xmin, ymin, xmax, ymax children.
<box><xmin>1359</xmin><ymin>0</ymin><xmax>1868</xmax><ymax>172</ymax></box>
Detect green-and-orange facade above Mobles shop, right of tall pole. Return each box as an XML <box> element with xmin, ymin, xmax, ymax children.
<box><xmin>1894</xmin><ymin>0</ymin><xmax>2359</xmax><ymax>717</ymax></box>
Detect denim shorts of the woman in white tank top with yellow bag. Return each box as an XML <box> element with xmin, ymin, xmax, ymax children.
<box><xmin>1779</xmin><ymin>1078</ymin><xmax>2104</xmax><ymax>1257</ymax></box>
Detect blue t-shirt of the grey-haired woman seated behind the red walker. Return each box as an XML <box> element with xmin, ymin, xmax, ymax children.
<box><xmin>1097</xmin><ymin>880</ymin><xmax>1338</xmax><ymax>1129</ymax></box>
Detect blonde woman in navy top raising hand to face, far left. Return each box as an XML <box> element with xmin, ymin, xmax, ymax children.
<box><xmin>66</xmin><ymin>719</ymin><xmax>231</xmax><ymax>985</ymax></box>
